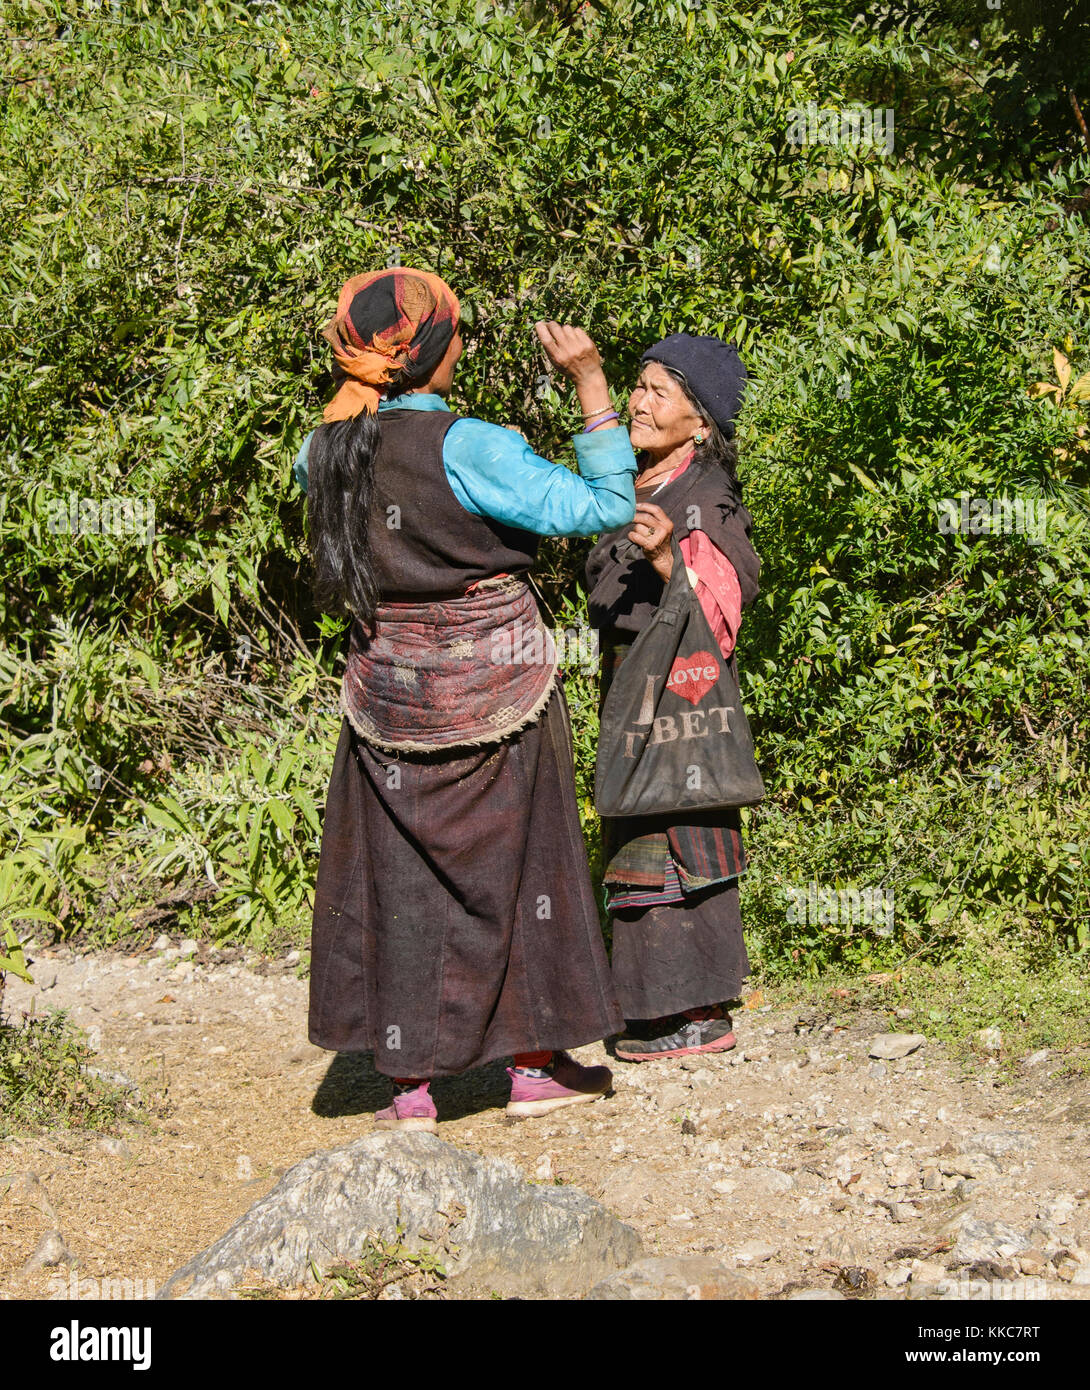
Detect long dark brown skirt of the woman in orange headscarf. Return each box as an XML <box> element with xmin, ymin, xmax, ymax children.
<box><xmin>310</xmin><ymin>687</ymin><xmax>623</xmax><ymax>1076</ymax></box>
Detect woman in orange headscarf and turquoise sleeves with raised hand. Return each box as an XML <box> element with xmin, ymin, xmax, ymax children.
<box><xmin>296</xmin><ymin>268</ymin><xmax>635</xmax><ymax>1131</ymax></box>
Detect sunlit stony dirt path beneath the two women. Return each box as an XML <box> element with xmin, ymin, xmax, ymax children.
<box><xmin>0</xmin><ymin>945</ymin><xmax>1090</xmax><ymax>1298</ymax></box>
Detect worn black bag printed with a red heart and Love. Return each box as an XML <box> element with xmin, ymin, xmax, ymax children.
<box><xmin>594</xmin><ymin>538</ymin><xmax>765</xmax><ymax>816</ymax></box>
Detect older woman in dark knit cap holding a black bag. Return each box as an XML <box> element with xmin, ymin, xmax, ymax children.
<box><xmin>587</xmin><ymin>334</ymin><xmax>760</xmax><ymax>1062</ymax></box>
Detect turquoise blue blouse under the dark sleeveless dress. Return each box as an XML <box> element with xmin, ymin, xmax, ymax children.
<box><xmin>295</xmin><ymin>392</ymin><xmax>635</xmax><ymax>535</ymax></box>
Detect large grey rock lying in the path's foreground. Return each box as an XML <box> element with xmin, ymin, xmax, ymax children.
<box><xmin>157</xmin><ymin>1133</ymin><xmax>642</xmax><ymax>1298</ymax></box>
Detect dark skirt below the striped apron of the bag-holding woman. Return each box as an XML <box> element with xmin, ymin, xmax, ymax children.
<box><xmin>612</xmin><ymin>881</ymin><xmax>749</xmax><ymax>1019</ymax></box>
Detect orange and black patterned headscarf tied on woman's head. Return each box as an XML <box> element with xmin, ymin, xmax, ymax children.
<box><xmin>321</xmin><ymin>265</ymin><xmax>462</xmax><ymax>424</ymax></box>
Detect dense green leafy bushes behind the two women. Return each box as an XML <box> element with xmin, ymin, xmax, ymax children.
<box><xmin>0</xmin><ymin>0</ymin><xmax>1090</xmax><ymax>1000</ymax></box>
